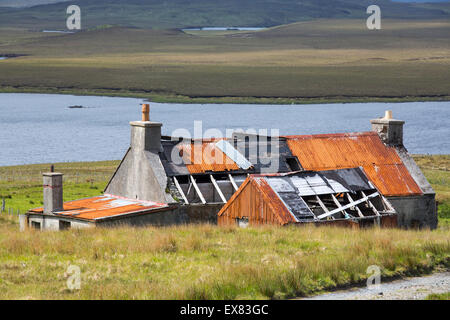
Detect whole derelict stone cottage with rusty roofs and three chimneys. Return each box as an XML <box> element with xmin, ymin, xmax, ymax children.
<box><xmin>20</xmin><ymin>105</ymin><xmax>437</xmax><ymax>230</ymax></box>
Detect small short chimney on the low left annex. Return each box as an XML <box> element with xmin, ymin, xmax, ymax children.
<box><xmin>43</xmin><ymin>172</ymin><xmax>64</xmax><ymax>214</ymax></box>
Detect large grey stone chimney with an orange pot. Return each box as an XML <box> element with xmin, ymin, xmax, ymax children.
<box><xmin>130</xmin><ymin>104</ymin><xmax>162</xmax><ymax>152</ymax></box>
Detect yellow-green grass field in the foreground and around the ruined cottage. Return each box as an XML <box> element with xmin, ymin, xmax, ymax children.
<box><xmin>0</xmin><ymin>155</ymin><xmax>450</xmax><ymax>299</ymax></box>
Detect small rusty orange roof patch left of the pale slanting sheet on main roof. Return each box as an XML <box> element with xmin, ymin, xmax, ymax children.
<box><xmin>177</xmin><ymin>140</ymin><xmax>240</xmax><ymax>174</ymax></box>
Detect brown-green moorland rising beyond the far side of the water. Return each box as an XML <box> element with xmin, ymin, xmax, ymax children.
<box><xmin>0</xmin><ymin>19</ymin><xmax>450</xmax><ymax>104</ymax></box>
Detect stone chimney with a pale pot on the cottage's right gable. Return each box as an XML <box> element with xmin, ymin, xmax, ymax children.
<box><xmin>370</xmin><ymin>110</ymin><xmax>405</xmax><ymax>146</ymax></box>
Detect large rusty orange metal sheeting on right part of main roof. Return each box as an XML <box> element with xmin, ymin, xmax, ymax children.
<box><xmin>285</xmin><ymin>132</ymin><xmax>422</xmax><ymax>196</ymax></box>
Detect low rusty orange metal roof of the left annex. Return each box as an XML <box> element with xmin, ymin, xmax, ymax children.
<box><xmin>30</xmin><ymin>195</ymin><xmax>168</xmax><ymax>221</ymax></box>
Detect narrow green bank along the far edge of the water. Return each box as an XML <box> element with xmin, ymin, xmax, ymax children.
<box><xmin>0</xmin><ymin>86</ymin><xmax>450</xmax><ymax>105</ymax></box>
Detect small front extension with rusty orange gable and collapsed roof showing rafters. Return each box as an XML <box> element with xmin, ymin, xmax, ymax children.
<box><xmin>218</xmin><ymin>168</ymin><xmax>396</xmax><ymax>225</ymax></box>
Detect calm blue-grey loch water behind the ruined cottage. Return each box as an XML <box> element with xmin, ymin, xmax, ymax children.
<box><xmin>0</xmin><ymin>94</ymin><xmax>450</xmax><ymax>166</ymax></box>
